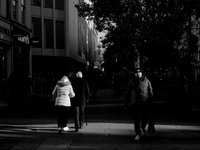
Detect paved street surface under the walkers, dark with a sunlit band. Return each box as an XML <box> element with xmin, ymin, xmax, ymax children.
<box><xmin>0</xmin><ymin>89</ymin><xmax>200</xmax><ymax>150</ymax></box>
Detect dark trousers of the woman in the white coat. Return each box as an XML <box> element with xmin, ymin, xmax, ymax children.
<box><xmin>56</xmin><ymin>106</ymin><xmax>69</xmax><ymax>128</ymax></box>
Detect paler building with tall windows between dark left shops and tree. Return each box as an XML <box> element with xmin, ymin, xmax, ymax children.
<box><xmin>31</xmin><ymin>0</ymin><xmax>98</xmax><ymax>95</ymax></box>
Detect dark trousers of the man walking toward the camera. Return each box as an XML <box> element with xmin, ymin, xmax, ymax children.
<box><xmin>131</xmin><ymin>104</ymin><xmax>149</xmax><ymax>134</ymax></box>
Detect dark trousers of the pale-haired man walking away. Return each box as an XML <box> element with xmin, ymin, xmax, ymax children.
<box><xmin>74</xmin><ymin>106</ymin><xmax>85</xmax><ymax>129</ymax></box>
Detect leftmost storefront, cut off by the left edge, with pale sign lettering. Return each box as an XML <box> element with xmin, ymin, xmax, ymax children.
<box><xmin>0</xmin><ymin>18</ymin><xmax>11</xmax><ymax>98</ymax></box>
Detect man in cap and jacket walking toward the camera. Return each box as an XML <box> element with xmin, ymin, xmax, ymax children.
<box><xmin>125</xmin><ymin>68</ymin><xmax>153</xmax><ymax>140</ymax></box>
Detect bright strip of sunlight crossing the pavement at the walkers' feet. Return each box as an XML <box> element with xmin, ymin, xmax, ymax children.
<box><xmin>0</xmin><ymin>122</ymin><xmax>200</xmax><ymax>136</ymax></box>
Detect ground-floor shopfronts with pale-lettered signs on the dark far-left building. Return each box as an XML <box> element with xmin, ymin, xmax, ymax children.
<box><xmin>0</xmin><ymin>17</ymin><xmax>31</xmax><ymax>99</ymax></box>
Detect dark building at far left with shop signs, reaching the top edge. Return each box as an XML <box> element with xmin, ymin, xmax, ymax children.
<box><xmin>0</xmin><ymin>0</ymin><xmax>31</xmax><ymax>97</ymax></box>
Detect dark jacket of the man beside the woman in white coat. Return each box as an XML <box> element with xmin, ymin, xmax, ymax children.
<box><xmin>72</xmin><ymin>78</ymin><xmax>90</xmax><ymax>107</ymax></box>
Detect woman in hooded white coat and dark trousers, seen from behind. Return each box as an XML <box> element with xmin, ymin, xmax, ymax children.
<box><xmin>52</xmin><ymin>76</ymin><xmax>75</xmax><ymax>133</ymax></box>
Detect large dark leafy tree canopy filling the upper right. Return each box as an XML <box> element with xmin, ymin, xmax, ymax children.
<box><xmin>75</xmin><ymin>0</ymin><xmax>200</xmax><ymax>77</ymax></box>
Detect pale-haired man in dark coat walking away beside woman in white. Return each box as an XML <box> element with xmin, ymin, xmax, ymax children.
<box><xmin>72</xmin><ymin>71</ymin><xmax>90</xmax><ymax>132</ymax></box>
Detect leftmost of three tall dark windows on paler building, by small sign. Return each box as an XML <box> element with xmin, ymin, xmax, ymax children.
<box><xmin>32</xmin><ymin>17</ymin><xmax>42</xmax><ymax>47</ymax></box>
